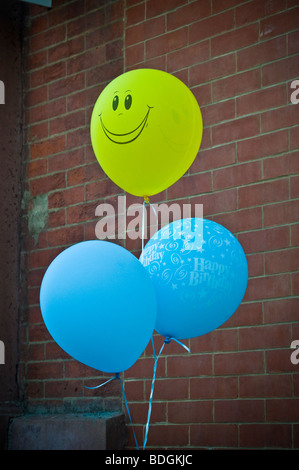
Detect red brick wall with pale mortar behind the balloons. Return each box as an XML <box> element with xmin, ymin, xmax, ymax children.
<box><xmin>21</xmin><ymin>0</ymin><xmax>299</xmax><ymax>448</ymax></box>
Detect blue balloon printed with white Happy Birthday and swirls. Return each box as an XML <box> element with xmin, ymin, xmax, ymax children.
<box><xmin>140</xmin><ymin>218</ymin><xmax>248</xmax><ymax>339</ymax></box>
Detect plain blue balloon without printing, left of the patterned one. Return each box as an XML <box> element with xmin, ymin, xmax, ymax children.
<box><xmin>40</xmin><ymin>240</ymin><xmax>157</xmax><ymax>373</ymax></box>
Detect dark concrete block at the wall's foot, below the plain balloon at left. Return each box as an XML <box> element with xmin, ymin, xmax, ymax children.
<box><xmin>8</xmin><ymin>413</ymin><xmax>126</xmax><ymax>450</ymax></box>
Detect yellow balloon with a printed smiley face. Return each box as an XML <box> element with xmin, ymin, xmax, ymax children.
<box><xmin>90</xmin><ymin>69</ymin><xmax>202</xmax><ymax>197</ymax></box>
